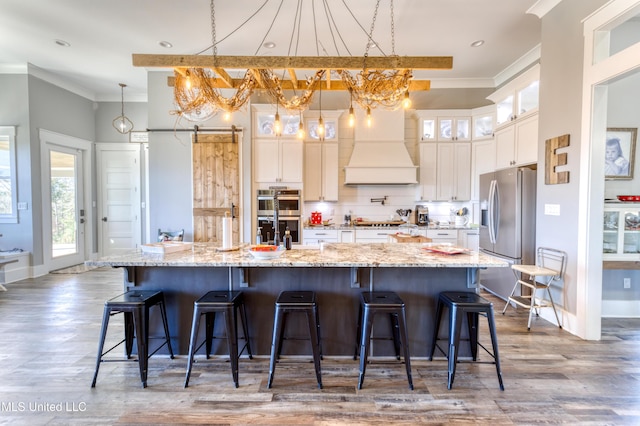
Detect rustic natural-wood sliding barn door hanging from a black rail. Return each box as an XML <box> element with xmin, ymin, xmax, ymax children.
<box><xmin>191</xmin><ymin>133</ymin><xmax>242</xmax><ymax>245</ymax></box>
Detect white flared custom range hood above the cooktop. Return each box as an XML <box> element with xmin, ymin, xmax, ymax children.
<box><xmin>344</xmin><ymin>109</ymin><xmax>418</xmax><ymax>185</ymax></box>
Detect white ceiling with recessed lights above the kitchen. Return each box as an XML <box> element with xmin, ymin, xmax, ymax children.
<box><xmin>0</xmin><ymin>0</ymin><xmax>558</xmax><ymax>101</ymax></box>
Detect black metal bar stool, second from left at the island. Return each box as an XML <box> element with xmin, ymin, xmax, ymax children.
<box><xmin>184</xmin><ymin>291</ymin><xmax>253</xmax><ymax>388</ymax></box>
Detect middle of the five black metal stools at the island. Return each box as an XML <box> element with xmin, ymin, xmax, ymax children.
<box><xmin>267</xmin><ymin>291</ymin><xmax>322</xmax><ymax>389</ymax></box>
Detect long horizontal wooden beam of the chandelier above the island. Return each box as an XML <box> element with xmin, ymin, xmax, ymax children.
<box><xmin>133</xmin><ymin>53</ymin><xmax>453</xmax><ymax>70</ymax></box>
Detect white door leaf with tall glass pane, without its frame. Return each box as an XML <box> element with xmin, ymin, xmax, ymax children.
<box><xmin>43</xmin><ymin>143</ymin><xmax>86</xmax><ymax>270</ymax></box>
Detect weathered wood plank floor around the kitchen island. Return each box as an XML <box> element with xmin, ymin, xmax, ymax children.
<box><xmin>0</xmin><ymin>269</ymin><xmax>640</xmax><ymax>425</ymax></box>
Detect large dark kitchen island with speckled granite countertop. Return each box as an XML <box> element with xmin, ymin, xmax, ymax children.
<box><xmin>86</xmin><ymin>243</ymin><xmax>508</xmax><ymax>357</ymax></box>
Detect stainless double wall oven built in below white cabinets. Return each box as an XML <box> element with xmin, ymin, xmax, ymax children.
<box><xmin>257</xmin><ymin>188</ymin><xmax>302</xmax><ymax>244</ymax></box>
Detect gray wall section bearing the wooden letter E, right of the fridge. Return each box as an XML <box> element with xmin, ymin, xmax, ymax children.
<box><xmin>536</xmin><ymin>0</ymin><xmax>606</xmax><ymax>314</ymax></box>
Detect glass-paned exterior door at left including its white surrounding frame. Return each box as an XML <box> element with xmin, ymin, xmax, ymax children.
<box><xmin>40</xmin><ymin>130</ymin><xmax>91</xmax><ymax>272</ymax></box>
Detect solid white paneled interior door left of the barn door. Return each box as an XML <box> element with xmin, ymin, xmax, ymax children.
<box><xmin>96</xmin><ymin>144</ymin><xmax>142</xmax><ymax>256</ymax></box>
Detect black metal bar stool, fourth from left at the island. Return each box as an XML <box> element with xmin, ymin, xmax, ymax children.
<box><xmin>353</xmin><ymin>291</ymin><xmax>413</xmax><ymax>390</ymax></box>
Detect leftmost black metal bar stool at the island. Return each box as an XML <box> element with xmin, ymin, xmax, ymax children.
<box><xmin>91</xmin><ymin>290</ymin><xmax>173</xmax><ymax>388</ymax></box>
